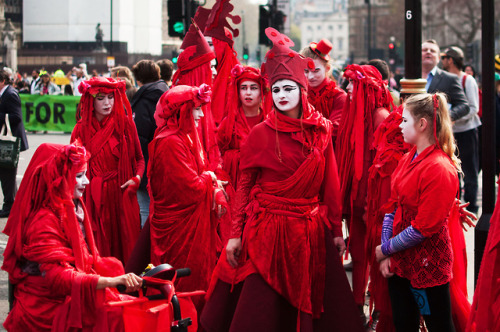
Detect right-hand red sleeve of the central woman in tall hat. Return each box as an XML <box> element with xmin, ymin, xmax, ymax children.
<box><xmin>321</xmin><ymin>143</ymin><xmax>342</xmax><ymax>237</ymax></box>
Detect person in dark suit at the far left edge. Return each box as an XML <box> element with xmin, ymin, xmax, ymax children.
<box><xmin>0</xmin><ymin>70</ymin><xmax>28</xmax><ymax>218</ymax></box>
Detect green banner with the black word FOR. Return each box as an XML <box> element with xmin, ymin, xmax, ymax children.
<box><xmin>19</xmin><ymin>94</ymin><xmax>80</xmax><ymax>133</ymax></box>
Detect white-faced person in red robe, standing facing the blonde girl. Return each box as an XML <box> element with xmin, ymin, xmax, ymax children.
<box><xmin>335</xmin><ymin>65</ymin><xmax>392</xmax><ymax>317</ymax></box>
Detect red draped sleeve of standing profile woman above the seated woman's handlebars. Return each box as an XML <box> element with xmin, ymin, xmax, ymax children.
<box><xmin>150</xmin><ymin>135</ymin><xmax>214</xmax><ymax>201</ymax></box>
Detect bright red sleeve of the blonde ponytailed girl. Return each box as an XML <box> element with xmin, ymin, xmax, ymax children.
<box><xmin>411</xmin><ymin>162</ymin><xmax>458</xmax><ymax>237</ymax></box>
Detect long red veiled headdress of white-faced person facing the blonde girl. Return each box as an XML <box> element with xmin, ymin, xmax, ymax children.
<box><xmin>337</xmin><ymin>65</ymin><xmax>393</xmax><ymax>209</ymax></box>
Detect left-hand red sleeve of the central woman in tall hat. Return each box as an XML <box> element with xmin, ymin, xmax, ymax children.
<box><xmin>229</xmin><ymin>168</ymin><xmax>258</xmax><ymax>239</ymax></box>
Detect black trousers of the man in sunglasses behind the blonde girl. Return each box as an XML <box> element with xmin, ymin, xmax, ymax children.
<box><xmin>454</xmin><ymin>128</ymin><xmax>479</xmax><ymax>213</ymax></box>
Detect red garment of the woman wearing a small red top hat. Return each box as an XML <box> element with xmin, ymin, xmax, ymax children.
<box><xmin>307</xmin><ymin>78</ymin><xmax>347</xmax><ymax>144</ymax></box>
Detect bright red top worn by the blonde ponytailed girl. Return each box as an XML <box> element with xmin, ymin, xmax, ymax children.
<box><xmin>389</xmin><ymin>145</ymin><xmax>458</xmax><ymax>288</ymax></box>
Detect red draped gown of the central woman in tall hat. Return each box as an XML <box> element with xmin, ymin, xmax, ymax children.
<box><xmin>202</xmin><ymin>112</ymin><xmax>361</xmax><ymax>331</ymax></box>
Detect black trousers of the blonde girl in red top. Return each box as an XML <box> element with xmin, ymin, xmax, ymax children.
<box><xmin>388</xmin><ymin>275</ymin><xmax>455</xmax><ymax>332</ymax></box>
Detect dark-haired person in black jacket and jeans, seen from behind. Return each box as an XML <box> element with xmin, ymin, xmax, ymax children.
<box><xmin>131</xmin><ymin>60</ymin><xmax>168</xmax><ymax>226</ymax></box>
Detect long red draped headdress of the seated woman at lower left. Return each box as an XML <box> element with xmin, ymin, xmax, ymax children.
<box><xmin>2</xmin><ymin>142</ymin><xmax>95</xmax><ymax>282</ymax></box>
